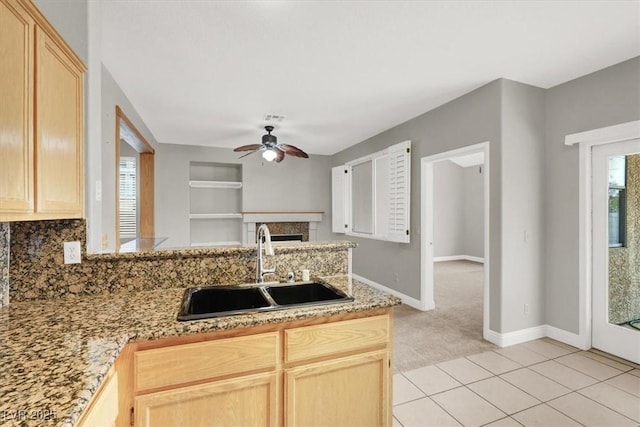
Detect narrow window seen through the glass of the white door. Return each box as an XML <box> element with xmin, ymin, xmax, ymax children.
<box><xmin>609</xmin><ymin>156</ymin><xmax>627</xmax><ymax>248</ymax></box>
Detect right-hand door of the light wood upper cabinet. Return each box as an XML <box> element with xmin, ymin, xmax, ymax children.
<box><xmin>35</xmin><ymin>28</ymin><xmax>84</xmax><ymax>218</ymax></box>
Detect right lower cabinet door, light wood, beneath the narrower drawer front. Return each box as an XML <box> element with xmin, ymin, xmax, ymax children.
<box><xmin>285</xmin><ymin>350</ymin><xmax>391</xmax><ymax>427</ymax></box>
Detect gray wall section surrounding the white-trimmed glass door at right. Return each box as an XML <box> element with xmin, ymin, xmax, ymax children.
<box><xmin>544</xmin><ymin>58</ymin><xmax>640</xmax><ymax>333</ymax></box>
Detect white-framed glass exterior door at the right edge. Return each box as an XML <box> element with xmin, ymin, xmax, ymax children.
<box><xmin>591</xmin><ymin>139</ymin><xmax>640</xmax><ymax>363</ymax></box>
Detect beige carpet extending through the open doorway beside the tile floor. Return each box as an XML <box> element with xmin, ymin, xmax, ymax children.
<box><xmin>394</xmin><ymin>261</ymin><xmax>497</xmax><ymax>372</ymax></box>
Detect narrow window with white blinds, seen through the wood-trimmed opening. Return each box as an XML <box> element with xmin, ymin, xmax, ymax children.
<box><xmin>119</xmin><ymin>157</ymin><xmax>138</xmax><ymax>243</ymax></box>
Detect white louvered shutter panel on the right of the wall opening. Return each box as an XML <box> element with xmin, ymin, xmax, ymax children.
<box><xmin>387</xmin><ymin>141</ymin><xmax>411</xmax><ymax>243</ymax></box>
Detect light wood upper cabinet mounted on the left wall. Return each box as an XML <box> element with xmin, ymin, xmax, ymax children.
<box><xmin>0</xmin><ymin>0</ymin><xmax>86</xmax><ymax>221</ymax></box>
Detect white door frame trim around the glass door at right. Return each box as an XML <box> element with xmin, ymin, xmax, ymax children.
<box><xmin>563</xmin><ymin>120</ymin><xmax>640</xmax><ymax>350</ymax></box>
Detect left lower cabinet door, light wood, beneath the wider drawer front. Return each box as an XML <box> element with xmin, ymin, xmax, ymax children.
<box><xmin>135</xmin><ymin>373</ymin><xmax>279</xmax><ymax>427</ymax></box>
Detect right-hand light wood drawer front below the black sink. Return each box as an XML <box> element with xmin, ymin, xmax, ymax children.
<box><xmin>284</xmin><ymin>315</ymin><xmax>390</xmax><ymax>362</ymax></box>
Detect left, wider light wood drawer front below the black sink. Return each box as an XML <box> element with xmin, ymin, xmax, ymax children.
<box><xmin>134</xmin><ymin>332</ymin><xmax>278</xmax><ymax>391</ymax></box>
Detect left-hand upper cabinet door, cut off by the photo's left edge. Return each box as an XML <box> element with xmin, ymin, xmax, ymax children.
<box><xmin>0</xmin><ymin>0</ymin><xmax>34</xmax><ymax>216</ymax></box>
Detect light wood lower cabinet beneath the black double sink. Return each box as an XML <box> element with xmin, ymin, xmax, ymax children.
<box><xmin>108</xmin><ymin>309</ymin><xmax>392</xmax><ymax>427</ymax></box>
